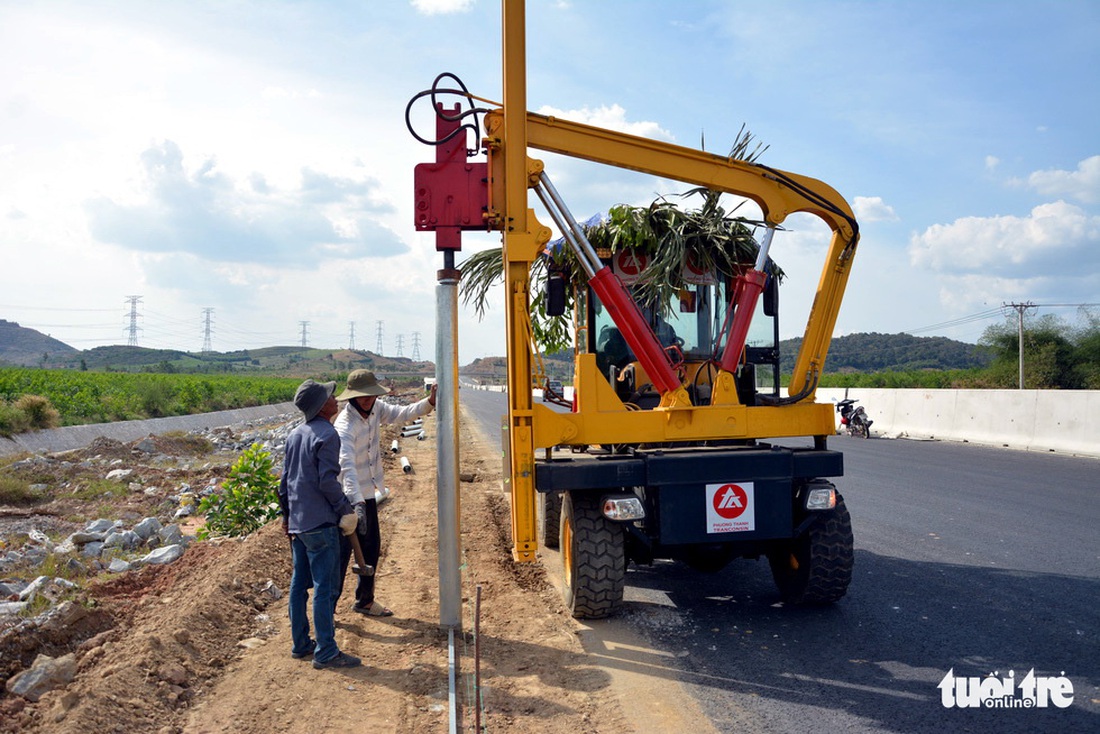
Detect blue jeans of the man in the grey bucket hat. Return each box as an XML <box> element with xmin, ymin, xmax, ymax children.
<box><xmin>287</xmin><ymin>527</ymin><xmax>340</xmax><ymax>662</ymax></box>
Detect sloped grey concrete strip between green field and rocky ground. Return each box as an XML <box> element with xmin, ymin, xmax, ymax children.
<box><xmin>0</xmin><ymin>403</ymin><xmax>301</xmax><ymax>456</ymax></box>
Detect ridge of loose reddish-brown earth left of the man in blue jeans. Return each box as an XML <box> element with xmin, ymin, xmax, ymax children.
<box><xmin>4</xmin><ymin>525</ymin><xmax>289</xmax><ymax>732</ymax></box>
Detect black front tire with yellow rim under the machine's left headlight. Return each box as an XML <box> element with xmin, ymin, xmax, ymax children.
<box><xmin>559</xmin><ymin>492</ymin><xmax>626</xmax><ymax>620</ymax></box>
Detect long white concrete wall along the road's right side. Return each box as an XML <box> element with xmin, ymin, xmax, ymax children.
<box><xmin>817</xmin><ymin>387</ymin><xmax>1100</xmax><ymax>457</ymax></box>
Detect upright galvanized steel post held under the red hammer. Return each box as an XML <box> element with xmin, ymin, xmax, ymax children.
<box><xmin>436</xmin><ymin>255</ymin><xmax>462</xmax><ymax>628</ymax></box>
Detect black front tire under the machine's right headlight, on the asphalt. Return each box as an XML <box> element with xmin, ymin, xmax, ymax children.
<box><xmin>768</xmin><ymin>492</ymin><xmax>855</xmax><ymax>605</ymax></box>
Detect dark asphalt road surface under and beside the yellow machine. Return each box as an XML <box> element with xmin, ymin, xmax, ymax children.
<box><xmin>462</xmin><ymin>390</ymin><xmax>1100</xmax><ymax>734</ymax></box>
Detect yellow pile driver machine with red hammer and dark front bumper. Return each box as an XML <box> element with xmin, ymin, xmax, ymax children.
<box><xmin>407</xmin><ymin>0</ymin><xmax>859</xmax><ymax>618</ymax></box>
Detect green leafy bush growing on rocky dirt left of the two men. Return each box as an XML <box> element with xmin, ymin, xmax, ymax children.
<box><xmin>198</xmin><ymin>443</ymin><xmax>279</xmax><ymax>540</ymax></box>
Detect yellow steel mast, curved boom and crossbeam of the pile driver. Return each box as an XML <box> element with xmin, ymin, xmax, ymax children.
<box><xmin>497</xmin><ymin>0</ymin><xmax>858</xmax><ymax>561</ymax></box>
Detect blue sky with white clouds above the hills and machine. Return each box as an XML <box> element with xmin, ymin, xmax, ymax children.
<box><xmin>0</xmin><ymin>0</ymin><xmax>1100</xmax><ymax>363</ymax></box>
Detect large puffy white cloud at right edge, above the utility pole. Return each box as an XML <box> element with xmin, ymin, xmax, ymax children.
<box><xmin>909</xmin><ymin>201</ymin><xmax>1100</xmax><ymax>277</ymax></box>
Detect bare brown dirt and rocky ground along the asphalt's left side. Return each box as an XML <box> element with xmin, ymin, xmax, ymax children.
<box><xmin>0</xmin><ymin>396</ymin><xmax>636</xmax><ymax>734</ymax></box>
